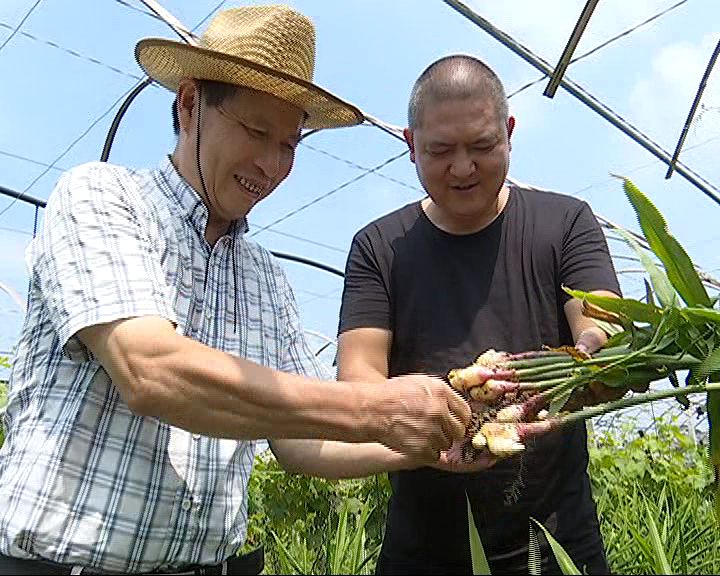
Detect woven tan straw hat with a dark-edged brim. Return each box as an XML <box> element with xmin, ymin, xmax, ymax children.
<box><xmin>135</xmin><ymin>5</ymin><xmax>364</xmax><ymax>128</ymax></box>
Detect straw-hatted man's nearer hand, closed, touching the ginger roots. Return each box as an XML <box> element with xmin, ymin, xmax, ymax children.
<box><xmin>377</xmin><ymin>374</ymin><xmax>470</xmax><ymax>465</ymax></box>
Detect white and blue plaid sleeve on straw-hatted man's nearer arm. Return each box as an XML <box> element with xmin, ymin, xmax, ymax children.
<box><xmin>30</xmin><ymin>163</ymin><xmax>176</xmax><ymax>360</ymax></box>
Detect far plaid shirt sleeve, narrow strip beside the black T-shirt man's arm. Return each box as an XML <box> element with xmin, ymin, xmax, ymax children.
<box><xmin>277</xmin><ymin>269</ymin><xmax>334</xmax><ymax>380</ymax></box>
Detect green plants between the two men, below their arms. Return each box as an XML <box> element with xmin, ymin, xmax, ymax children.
<box><xmin>244</xmin><ymin>452</ymin><xmax>391</xmax><ymax>574</ymax></box>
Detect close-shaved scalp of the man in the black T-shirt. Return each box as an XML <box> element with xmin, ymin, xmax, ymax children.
<box><xmin>408</xmin><ymin>55</ymin><xmax>508</xmax><ymax>130</ymax></box>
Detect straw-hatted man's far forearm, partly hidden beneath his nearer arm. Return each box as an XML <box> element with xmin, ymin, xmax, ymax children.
<box><xmin>271</xmin><ymin>440</ymin><xmax>419</xmax><ymax>479</ymax></box>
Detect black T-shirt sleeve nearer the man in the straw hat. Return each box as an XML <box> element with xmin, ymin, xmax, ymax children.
<box><xmin>338</xmin><ymin>231</ymin><xmax>392</xmax><ymax>334</ymax></box>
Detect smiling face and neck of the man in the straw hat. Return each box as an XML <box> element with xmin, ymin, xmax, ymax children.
<box><xmin>173</xmin><ymin>80</ymin><xmax>304</xmax><ymax>244</ymax></box>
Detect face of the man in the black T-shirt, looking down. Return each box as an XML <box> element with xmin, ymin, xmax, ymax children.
<box><xmin>405</xmin><ymin>98</ymin><xmax>515</xmax><ymax>225</ymax></box>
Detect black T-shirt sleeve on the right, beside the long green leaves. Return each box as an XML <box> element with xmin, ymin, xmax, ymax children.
<box><xmin>560</xmin><ymin>202</ymin><xmax>620</xmax><ymax>303</ymax></box>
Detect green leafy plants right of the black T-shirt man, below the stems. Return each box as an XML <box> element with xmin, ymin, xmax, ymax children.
<box><xmin>590</xmin><ymin>421</ymin><xmax>720</xmax><ymax>574</ymax></box>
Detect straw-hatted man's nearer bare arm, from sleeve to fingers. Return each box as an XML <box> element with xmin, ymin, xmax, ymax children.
<box><xmin>78</xmin><ymin>317</ymin><xmax>469</xmax><ymax>460</ymax></box>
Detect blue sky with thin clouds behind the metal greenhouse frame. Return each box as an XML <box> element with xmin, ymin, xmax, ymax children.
<box><xmin>0</xmin><ymin>0</ymin><xmax>720</xmax><ymax>374</ymax></box>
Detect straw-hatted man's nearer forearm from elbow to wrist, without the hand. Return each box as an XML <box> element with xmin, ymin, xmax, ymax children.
<box><xmin>95</xmin><ymin>321</ymin><xmax>381</xmax><ymax>442</ymax></box>
